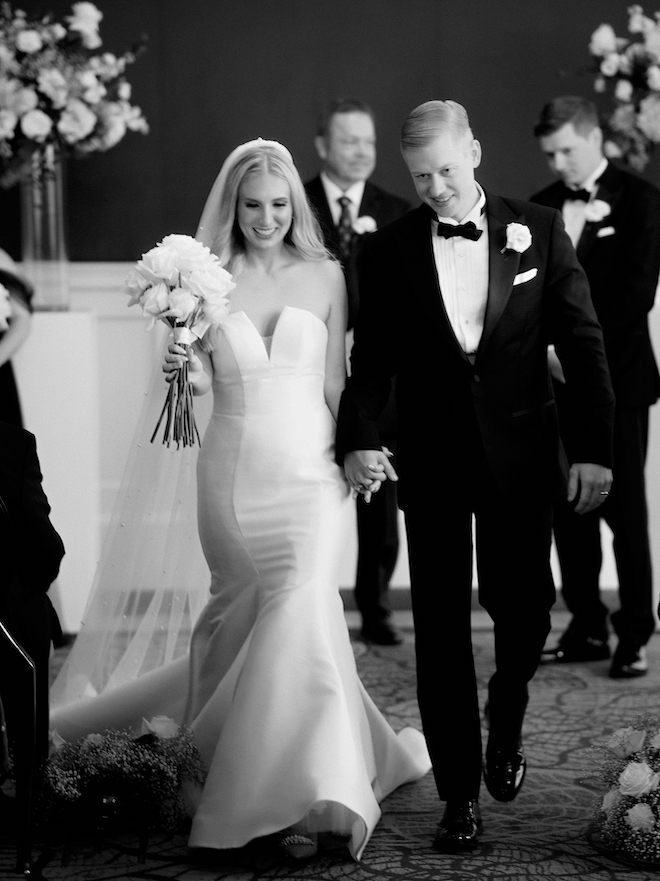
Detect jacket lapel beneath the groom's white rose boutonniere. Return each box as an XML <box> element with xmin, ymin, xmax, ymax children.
<box><xmin>477</xmin><ymin>193</ymin><xmax>525</xmax><ymax>359</ymax></box>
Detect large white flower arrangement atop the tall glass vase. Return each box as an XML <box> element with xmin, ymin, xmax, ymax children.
<box><xmin>0</xmin><ymin>3</ymin><xmax>149</xmax><ymax>186</ymax></box>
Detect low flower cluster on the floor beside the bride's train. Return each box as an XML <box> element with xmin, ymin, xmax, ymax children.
<box><xmin>37</xmin><ymin>716</ymin><xmax>206</xmax><ymax>831</ymax></box>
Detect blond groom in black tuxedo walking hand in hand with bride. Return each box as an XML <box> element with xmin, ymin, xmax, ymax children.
<box><xmin>337</xmin><ymin>101</ymin><xmax>614</xmax><ymax>853</ymax></box>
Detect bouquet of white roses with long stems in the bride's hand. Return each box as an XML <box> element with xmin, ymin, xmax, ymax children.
<box><xmin>126</xmin><ymin>235</ymin><xmax>235</xmax><ymax>448</ymax></box>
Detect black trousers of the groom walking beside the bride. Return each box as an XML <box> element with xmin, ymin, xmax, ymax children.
<box><xmin>405</xmin><ymin>426</ymin><xmax>555</xmax><ymax>800</ymax></box>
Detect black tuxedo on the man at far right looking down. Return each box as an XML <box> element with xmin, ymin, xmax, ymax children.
<box><xmin>532</xmin><ymin>163</ymin><xmax>660</xmax><ymax>648</ymax></box>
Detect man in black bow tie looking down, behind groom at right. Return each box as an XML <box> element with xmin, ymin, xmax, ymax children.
<box><xmin>532</xmin><ymin>96</ymin><xmax>660</xmax><ymax>679</ymax></box>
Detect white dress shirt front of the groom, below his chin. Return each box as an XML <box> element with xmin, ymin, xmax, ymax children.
<box><xmin>431</xmin><ymin>184</ymin><xmax>488</xmax><ymax>356</ymax></box>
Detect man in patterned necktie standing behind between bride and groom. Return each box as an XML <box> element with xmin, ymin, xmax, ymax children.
<box><xmin>305</xmin><ymin>98</ymin><xmax>410</xmax><ymax>645</ymax></box>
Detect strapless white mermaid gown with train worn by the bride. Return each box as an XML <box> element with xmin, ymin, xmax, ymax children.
<box><xmin>51</xmin><ymin>307</ymin><xmax>430</xmax><ymax>858</ymax></box>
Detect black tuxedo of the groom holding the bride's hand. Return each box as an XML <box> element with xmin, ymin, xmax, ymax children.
<box><xmin>337</xmin><ymin>194</ymin><xmax>613</xmax><ymax>798</ymax></box>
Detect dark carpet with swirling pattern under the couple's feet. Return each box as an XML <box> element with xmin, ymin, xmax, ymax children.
<box><xmin>0</xmin><ymin>623</ymin><xmax>660</xmax><ymax>881</ymax></box>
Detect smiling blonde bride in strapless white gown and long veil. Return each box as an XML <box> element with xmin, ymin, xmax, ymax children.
<box><xmin>51</xmin><ymin>139</ymin><xmax>430</xmax><ymax>859</ymax></box>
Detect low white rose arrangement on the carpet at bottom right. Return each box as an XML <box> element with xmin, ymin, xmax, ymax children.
<box><xmin>592</xmin><ymin>715</ymin><xmax>660</xmax><ymax>865</ymax></box>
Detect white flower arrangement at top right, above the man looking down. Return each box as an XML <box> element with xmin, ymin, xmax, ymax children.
<box><xmin>589</xmin><ymin>5</ymin><xmax>660</xmax><ymax>171</ymax></box>
